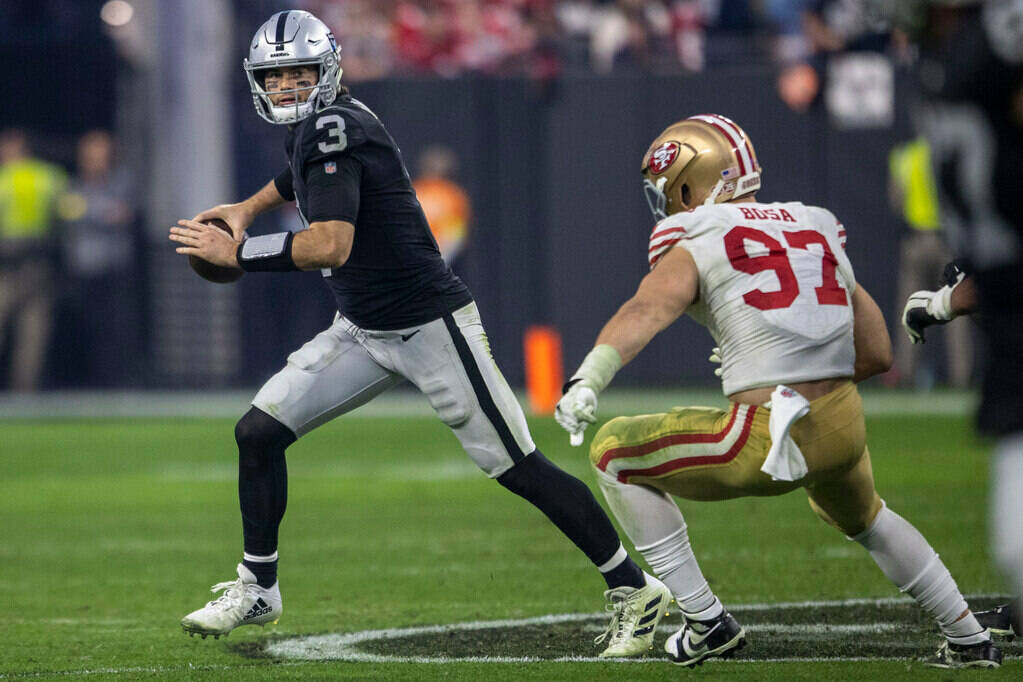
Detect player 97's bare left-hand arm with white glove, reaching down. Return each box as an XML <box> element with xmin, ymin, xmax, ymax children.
<box><xmin>554</xmin><ymin>248</ymin><xmax>700</xmax><ymax>446</ymax></box>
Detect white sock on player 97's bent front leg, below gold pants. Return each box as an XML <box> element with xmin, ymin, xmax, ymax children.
<box><xmin>597</xmin><ymin>471</ymin><xmax>724</xmax><ymax>621</ymax></box>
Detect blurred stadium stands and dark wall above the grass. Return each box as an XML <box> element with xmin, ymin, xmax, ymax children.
<box><xmin>0</xmin><ymin>0</ymin><xmax>945</xmax><ymax>404</ymax></box>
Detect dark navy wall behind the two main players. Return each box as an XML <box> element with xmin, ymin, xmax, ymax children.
<box><xmin>235</xmin><ymin>69</ymin><xmax>899</xmax><ymax>385</ymax></box>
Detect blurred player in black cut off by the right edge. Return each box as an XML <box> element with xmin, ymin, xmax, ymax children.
<box><xmin>891</xmin><ymin>0</ymin><xmax>1023</xmax><ymax>667</ymax></box>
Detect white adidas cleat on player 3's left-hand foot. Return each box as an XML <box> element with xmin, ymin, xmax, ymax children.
<box><xmin>181</xmin><ymin>563</ymin><xmax>283</xmax><ymax>639</ymax></box>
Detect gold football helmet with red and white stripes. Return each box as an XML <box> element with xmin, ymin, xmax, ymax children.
<box><xmin>642</xmin><ymin>113</ymin><xmax>760</xmax><ymax>220</ymax></box>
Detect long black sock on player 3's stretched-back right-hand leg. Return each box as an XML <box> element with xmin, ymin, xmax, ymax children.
<box><xmin>497</xmin><ymin>450</ymin><xmax>644</xmax><ymax>587</ymax></box>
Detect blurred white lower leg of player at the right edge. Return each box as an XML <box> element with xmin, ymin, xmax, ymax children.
<box><xmin>989</xmin><ymin>434</ymin><xmax>1023</xmax><ymax>594</ymax></box>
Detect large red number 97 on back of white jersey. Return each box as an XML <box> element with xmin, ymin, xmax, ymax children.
<box><xmin>724</xmin><ymin>225</ymin><xmax>848</xmax><ymax>310</ymax></box>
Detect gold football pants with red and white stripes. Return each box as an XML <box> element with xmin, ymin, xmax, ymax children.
<box><xmin>590</xmin><ymin>381</ymin><xmax>881</xmax><ymax>536</ymax></box>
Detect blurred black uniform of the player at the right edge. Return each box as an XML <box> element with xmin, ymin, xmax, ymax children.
<box><xmin>920</xmin><ymin>0</ymin><xmax>1023</xmax><ymax>436</ymax></box>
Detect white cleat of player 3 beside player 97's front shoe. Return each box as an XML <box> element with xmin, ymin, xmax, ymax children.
<box><xmin>593</xmin><ymin>574</ymin><xmax>672</xmax><ymax>658</ymax></box>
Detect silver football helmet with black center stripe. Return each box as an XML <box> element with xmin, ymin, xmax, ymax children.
<box><xmin>242</xmin><ymin>9</ymin><xmax>342</xmax><ymax>124</ymax></box>
